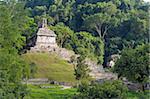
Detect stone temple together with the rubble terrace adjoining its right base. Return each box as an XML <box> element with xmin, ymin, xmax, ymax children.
<box><xmin>29</xmin><ymin>19</ymin><xmax>76</xmax><ymax>61</ymax></box>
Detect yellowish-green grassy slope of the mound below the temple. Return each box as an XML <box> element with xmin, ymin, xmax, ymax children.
<box><xmin>23</xmin><ymin>53</ymin><xmax>75</xmax><ymax>82</ymax></box>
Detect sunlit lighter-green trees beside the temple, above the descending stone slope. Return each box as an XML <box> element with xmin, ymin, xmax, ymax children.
<box><xmin>50</xmin><ymin>23</ymin><xmax>104</xmax><ymax>64</ymax></box>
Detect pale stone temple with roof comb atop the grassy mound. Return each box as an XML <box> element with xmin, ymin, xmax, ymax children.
<box><xmin>31</xmin><ymin>19</ymin><xmax>58</xmax><ymax>51</ymax></box>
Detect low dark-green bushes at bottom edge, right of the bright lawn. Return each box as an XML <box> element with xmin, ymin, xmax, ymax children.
<box><xmin>74</xmin><ymin>80</ymin><xmax>127</xmax><ymax>99</ymax></box>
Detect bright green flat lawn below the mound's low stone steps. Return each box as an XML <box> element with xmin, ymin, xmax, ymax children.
<box><xmin>25</xmin><ymin>85</ymin><xmax>76</xmax><ymax>99</ymax></box>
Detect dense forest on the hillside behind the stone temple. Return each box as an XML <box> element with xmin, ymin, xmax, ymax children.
<box><xmin>23</xmin><ymin>0</ymin><xmax>149</xmax><ymax>64</ymax></box>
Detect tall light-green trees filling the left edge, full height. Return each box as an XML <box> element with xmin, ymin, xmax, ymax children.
<box><xmin>0</xmin><ymin>1</ymin><xmax>29</xmax><ymax>99</ymax></box>
